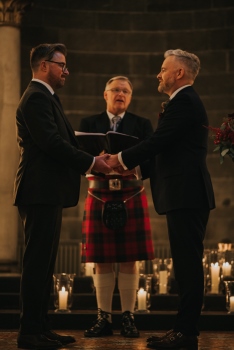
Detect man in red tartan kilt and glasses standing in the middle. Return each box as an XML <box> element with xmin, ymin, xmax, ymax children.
<box><xmin>79</xmin><ymin>76</ymin><xmax>154</xmax><ymax>338</ymax></box>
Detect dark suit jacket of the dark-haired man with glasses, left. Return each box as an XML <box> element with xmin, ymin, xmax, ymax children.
<box><xmin>14</xmin><ymin>81</ymin><xmax>93</xmax><ymax>207</ymax></box>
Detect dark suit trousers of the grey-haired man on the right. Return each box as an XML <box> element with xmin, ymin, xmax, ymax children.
<box><xmin>166</xmin><ymin>208</ymin><xmax>210</xmax><ymax>335</ymax></box>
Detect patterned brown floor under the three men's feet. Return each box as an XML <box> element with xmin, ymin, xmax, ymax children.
<box><xmin>0</xmin><ymin>330</ymin><xmax>234</xmax><ymax>350</ymax></box>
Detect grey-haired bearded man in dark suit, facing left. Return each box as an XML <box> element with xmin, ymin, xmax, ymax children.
<box><xmin>107</xmin><ymin>49</ymin><xmax>215</xmax><ymax>349</ymax></box>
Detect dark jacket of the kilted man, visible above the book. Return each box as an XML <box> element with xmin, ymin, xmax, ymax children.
<box><xmin>79</xmin><ymin>112</ymin><xmax>153</xmax><ymax>140</ymax></box>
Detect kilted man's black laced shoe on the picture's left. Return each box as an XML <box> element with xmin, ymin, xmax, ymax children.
<box><xmin>84</xmin><ymin>309</ymin><xmax>113</xmax><ymax>338</ymax></box>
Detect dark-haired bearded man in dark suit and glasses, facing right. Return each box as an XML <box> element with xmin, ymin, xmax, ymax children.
<box><xmin>14</xmin><ymin>44</ymin><xmax>111</xmax><ymax>349</ymax></box>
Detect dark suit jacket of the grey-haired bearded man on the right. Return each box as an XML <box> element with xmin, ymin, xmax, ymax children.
<box><xmin>122</xmin><ymin>87</ymin><xmax>215</xmax><ymax>214</ymax></box>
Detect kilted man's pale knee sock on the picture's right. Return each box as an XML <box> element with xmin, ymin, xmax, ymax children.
<box><xmin>118</xmin><ymin>272</ymin><xmax>139</xmax><ymax>312</ymax></box>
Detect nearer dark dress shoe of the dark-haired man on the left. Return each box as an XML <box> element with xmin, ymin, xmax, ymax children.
<box><xmin>17</xmin><ymin>334</ymin><xmax>63</xmax><ymax>350</ymax></box>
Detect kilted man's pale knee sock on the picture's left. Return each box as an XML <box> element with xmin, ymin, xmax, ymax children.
<box><xmin>93</xmin><ymin>272</ymin><xmax>115</xmax><ymax>321</ymax></box>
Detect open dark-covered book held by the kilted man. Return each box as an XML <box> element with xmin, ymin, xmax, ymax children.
<box><xmin>75</xmin><ymin>131</ymin><xmax>140</xmax><ymax>156</ymax></box>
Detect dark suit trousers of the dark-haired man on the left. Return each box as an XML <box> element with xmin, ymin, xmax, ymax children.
<box><xmin>18</xmin><ymin>205</ymin><xmax>62</xmax><ymax>334</ymax></box>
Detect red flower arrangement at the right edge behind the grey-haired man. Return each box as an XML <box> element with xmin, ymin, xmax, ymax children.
<box><xmin>208</xmin><ymin>113</ymin><xmax>234</xmax><ymax>164</ymax></box>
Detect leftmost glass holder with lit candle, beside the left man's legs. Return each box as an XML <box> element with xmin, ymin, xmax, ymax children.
<box><xmin>53</xmin><ymin>273</ymin><xmax>75</xmax><ymax>313</ymax></box>
